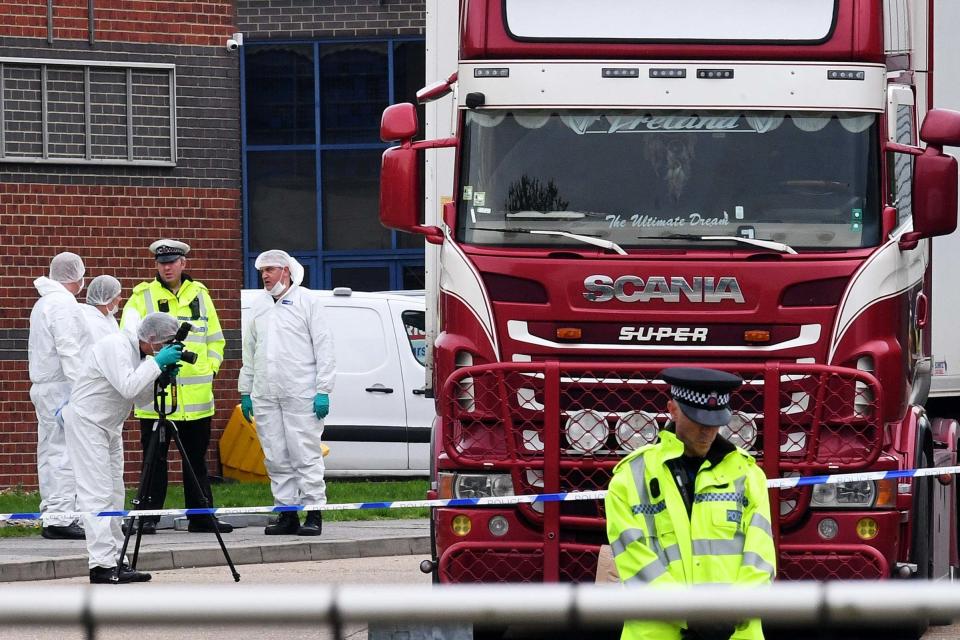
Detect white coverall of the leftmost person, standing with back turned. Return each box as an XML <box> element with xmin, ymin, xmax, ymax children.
<box><xmin>27</xmin><ymin>277</ymin><xmax>90</xmax><ymax>526</ymax></box>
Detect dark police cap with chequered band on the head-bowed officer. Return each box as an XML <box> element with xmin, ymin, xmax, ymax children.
<box><xmin>660</xmin><ymin>367</ymin><xmax>743</xmax><ymax>427</ymax></box>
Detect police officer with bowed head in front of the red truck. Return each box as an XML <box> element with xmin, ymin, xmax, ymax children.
<box><xmin>605</xmin><ymin>367</ymin><xmax>776</xmax><ymax>640</ymax></box>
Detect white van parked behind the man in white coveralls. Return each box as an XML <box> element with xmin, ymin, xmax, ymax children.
<box><xmin>240</xmin><ymin>287</ymin><xmax>435</xmax><ymax>477</ymax></box>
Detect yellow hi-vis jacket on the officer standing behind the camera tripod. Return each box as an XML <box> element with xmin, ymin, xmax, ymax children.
<box><xmin>120</xmin><ymin>274</ymin><xmax>226</xmax><ymax>422</ymax></box>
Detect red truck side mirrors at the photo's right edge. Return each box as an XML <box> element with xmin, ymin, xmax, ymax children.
<box><xmin>900</xmin><ymin>109</ymin><xmax>960</xmax><ymax>249</ymax></box>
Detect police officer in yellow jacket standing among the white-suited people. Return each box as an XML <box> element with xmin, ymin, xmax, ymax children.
<box><xmin>120</xmin><ymin>240</ymin><xmax>233</xmax><ymax>534</ymax></box>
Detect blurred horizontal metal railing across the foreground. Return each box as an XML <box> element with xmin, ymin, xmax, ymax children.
<box><xmin>0</xmin><ymin>581</ymin><xmax>960</xmax><ymax>637</ymax></box>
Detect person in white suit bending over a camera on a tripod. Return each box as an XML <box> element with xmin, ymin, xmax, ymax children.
<box><xmin>63</xmin><ymin>312</ymin><xmax>183</xmax><ymax>584</ymax></box>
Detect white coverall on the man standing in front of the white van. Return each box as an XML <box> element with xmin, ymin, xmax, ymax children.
<box><xmin>238</xmin><ymin>284</ymin><xmax>336</xmax><ymax>505</ymax></box>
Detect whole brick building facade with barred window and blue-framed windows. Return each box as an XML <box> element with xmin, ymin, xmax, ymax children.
<box><xmin>0</xmin><ymin>0</ymin><xmax>424</xmax><ymax>489</ymax></box>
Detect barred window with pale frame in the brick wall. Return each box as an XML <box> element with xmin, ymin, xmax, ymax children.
<box><xmin>0</xmin><ymin>58</ymin><xmax>177</xmax><ymax>167</ymax></box>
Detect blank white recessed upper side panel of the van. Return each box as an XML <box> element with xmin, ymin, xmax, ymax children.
<box><xmin>326</xmin><ymin>306</ymin><xmax>387</xmax><ymax>373</ymax></box>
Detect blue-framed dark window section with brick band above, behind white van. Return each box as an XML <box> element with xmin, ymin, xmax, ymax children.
<box><xmin>237</xmin><ymin>0</ymin><xmax>424</xmax><ymax>291</ymax></box>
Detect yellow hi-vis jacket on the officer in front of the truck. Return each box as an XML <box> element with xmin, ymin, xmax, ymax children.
<box><xmin>605</xmin><ymin>431</ymin><xmax>776</xmax><ymax>640</ymax></box>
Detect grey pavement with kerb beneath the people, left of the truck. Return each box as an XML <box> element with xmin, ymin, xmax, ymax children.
<box><xmin>0</xmin><ymin>516</ymin><xmax>430</xmax><ymax>582</ymax></box>
